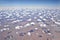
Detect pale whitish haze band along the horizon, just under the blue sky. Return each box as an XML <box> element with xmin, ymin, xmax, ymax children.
<box><xmin>0</xmin><ymin>6</ymin><xmax>60</xmax><ymax>9</ymax></box>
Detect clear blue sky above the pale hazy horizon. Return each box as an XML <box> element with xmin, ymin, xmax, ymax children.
<box><xmin>0</xmin><ymin>0</ymin><xmax>60</xmax><ymax>6</ymax></box>
